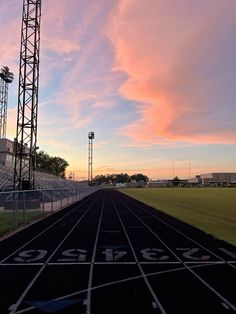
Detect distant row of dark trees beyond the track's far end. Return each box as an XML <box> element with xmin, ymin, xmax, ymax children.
<box><xmin>93</xmin><ymin>173</ymin><xmax>149</xmax><ymax>185</ymax></box>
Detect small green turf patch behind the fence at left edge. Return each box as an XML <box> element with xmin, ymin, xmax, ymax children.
<box><xmin>0</xmin><ymin>211</ymin><xmax>42</xmax><ymax>235</ymax></box>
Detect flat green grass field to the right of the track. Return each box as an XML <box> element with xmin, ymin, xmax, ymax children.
<box><xmin>121</xmin><ymin>188</ymin><xmax>236</xmax><ymax>245</ymax></box>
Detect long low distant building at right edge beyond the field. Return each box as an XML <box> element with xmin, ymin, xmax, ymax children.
<box><xmin>200</xmin><ymin>172</ymin><xmax>236</xmax><ymax>185</ymax></box>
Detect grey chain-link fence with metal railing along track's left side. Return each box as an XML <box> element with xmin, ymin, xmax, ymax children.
<box><xmin>0</xmin><ymin>187</ymin><xmax>98</xmax><ymax>235</ymax></box>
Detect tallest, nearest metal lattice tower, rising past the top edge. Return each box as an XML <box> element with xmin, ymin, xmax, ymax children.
<box><xmin>14</xmin><ymin>0</ymin><xmax>41</xmax><ymax>190</ymax></box>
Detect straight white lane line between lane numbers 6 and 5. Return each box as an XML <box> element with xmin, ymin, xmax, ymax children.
<box><xmin>10</xmin><ymin>198</ymin><xmax>98</xmax><ymax>314</ymax></box>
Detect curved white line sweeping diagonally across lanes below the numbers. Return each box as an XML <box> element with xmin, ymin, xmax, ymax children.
<box><xmin>15</xmin><ymin>265</ymin><xmax>214</xmax><ymax>314</ymax></box>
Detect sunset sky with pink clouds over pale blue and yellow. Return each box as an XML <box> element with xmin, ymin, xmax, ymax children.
<box><xmin>0</xmin><ymin>0</ymin><xmax>236</xmax><ymax>180</ymax></box>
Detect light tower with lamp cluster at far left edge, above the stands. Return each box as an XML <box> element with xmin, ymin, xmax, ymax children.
<box><xmin>0</xmin><ymin>66</ymin><xmax>14</xmax><ymax>138</ymax></box>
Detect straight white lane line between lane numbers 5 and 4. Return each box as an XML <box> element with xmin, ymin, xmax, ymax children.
<box><xmin>86</xmin><ymin>196</ymin><xmax>105</xmax><ymax>314</ymax></box>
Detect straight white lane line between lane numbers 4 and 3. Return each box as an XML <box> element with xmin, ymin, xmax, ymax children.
<box><xmin>111</xmin><ymin>198</ymin><xmax>166</xmax><ymax>314</ymax></box>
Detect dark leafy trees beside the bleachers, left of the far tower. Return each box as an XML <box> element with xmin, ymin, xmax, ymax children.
<box><xmin>35</xmin><ymin>150</ymin><xmax>69</xmax><ymax>178</ymax></box>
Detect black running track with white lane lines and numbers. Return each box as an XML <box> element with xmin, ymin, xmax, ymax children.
<box><xmin>0</xmin><ymin>190</ymin><xmax>236</xmax><ymax>314</ymax></box>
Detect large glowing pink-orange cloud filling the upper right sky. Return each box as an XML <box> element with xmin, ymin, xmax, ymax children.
<box><xmin>107</xmin><ymin>0</ymin><xmax>236</xmax><ymax>144</ymax></box>
